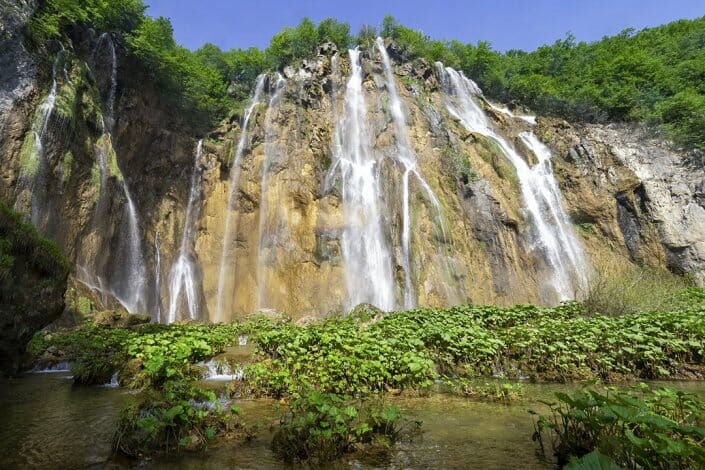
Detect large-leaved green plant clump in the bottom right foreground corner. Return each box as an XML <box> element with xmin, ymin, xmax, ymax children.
<box><xmin>534</xmin><ymin>384</ymin><xmax>705</xmax><ymax>469</ymax></box>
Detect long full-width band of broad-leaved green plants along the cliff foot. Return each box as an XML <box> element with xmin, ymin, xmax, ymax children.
<box><xmin>30</xmin><ymin>289</ymin><xmax>705</xmax><ymax>397</ymax></box>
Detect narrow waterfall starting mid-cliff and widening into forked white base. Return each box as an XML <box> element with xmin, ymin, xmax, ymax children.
<box><xmin>166</xmin><ymin>140</ymin><xmax>203</xmax><ymax>323</ymax></box>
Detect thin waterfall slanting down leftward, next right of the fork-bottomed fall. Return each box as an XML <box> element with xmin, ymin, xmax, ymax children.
<box><xmin>215</xmin><ymin>75</ymin><xmax>265</xmax><ymax>322</ymax></box>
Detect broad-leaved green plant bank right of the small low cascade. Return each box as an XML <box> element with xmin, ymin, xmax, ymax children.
<box><xmin>247</xmin><ymin>299</ymin><xmax>705</xmax><ymax>396</ymax></box>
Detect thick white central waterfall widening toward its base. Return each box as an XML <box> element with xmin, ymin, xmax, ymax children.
<box><xmin>326</xmin><ymin>49</ymin><xmax>395</xmax><ymax>310</ymax></box>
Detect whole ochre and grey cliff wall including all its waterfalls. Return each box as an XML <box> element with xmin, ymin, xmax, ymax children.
<box><xmin>0</xmin><ymin>7</ymin><xmax>705</xmax><ymax>322</ymax></box>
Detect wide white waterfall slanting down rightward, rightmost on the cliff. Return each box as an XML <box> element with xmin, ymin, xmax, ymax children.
<box><xmin>436</xmin><ymin>64</ymin><xmax>589</xmax><ymax>300</ymax></box>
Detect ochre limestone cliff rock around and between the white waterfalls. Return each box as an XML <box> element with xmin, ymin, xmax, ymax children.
<box><xmin>0</xmin><ymin>22</ymin><xmax>705</xmax><ymax>321</ymax></box>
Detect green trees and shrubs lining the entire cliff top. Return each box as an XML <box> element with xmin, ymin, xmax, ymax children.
<box><xmin>28</xmin><ymin>0</ymin><xmax>705</xmax><ymax>149</ymax></box>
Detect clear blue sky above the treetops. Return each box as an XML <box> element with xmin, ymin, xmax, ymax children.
<box><xmin>144</xmin><ymin>0</ymin><xmax>705</xmax><ymax>51</ymax></box>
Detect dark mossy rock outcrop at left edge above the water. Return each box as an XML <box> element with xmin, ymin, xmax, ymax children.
<box><xmin>0</xmin><ymin>203</ymin><xmax>70</xmax><ymax>375</ymax></box>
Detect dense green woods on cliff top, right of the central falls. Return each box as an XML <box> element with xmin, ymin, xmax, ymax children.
<box><xmin>382</xmin><ymin>16</ymin><xmax>705</xmax><ymax>149</ymax></box>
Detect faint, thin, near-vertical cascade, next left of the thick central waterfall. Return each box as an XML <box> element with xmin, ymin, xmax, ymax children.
<box><xmin>257</xmin><ymin>74</ymin><xmax>286</xmax><ymax>309</ymax></box>
